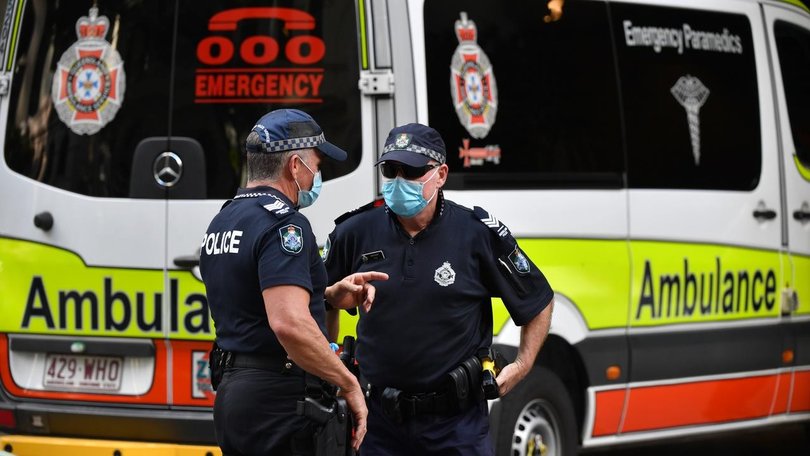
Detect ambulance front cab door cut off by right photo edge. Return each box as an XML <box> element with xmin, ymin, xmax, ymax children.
<box><xmin>763</xmin><ymin>0</ymin><xmax>810</xmax><ymax>417</ymax></box>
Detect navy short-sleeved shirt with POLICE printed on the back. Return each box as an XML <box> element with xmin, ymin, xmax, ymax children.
<box><xmin>200</xmin><ymin>187</ymin><xmax>326</xmax><ymax>357</ymax></box>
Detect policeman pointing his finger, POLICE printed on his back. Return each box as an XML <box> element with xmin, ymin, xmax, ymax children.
<box><xmin>200</xmin><ymin>109</ymin><xmax>385</xmax><ymax>455</ymax></box>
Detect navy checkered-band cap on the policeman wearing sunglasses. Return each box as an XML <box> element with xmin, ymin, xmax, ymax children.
<box><xmin>375</xmin><ymin>123</ymin><xmax>447</xmax><ymax>166</ymax></box>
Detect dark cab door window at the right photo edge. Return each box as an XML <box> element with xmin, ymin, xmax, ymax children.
<box><xmin>774</xmin><ymin>21</ymin><xmax>810</xmax><ymax>167</ymax></box>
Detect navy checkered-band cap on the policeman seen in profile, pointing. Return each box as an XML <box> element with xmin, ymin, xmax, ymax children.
<box><xmin>245</xmin><ymin>109</ymin><xmax>346</xmax><ymax>161</ymax></box>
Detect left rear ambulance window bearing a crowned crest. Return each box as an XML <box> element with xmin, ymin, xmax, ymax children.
<box><xmin>5</xmin><ymin>0</ymin><xmax>174</xmax><ymax>197</ymax></box>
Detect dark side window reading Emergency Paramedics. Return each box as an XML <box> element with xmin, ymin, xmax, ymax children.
<box><xmin>611</xmin><ymin>4</ymin><xmax>762</xmax><ymax>190</ymax></box>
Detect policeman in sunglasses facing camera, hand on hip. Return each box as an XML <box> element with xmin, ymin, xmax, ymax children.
<box><xmin>325</xmin><ymin>124</ymin><xmax>553</xmax><ymax>456</ymax></box>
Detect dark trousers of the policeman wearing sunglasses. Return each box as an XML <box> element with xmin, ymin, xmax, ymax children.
<box><xmin>360</xmin><ymin>396</ymin><xmax>495</xmax><ymax>456</ymax></box>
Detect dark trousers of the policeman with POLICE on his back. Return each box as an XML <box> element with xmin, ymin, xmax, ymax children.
<box><xmin>214</xmin><ymin>368</ymin><xmax>315</xmax><ymax>456</ymax></box>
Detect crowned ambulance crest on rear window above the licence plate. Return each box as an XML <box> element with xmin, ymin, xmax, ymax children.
<box><xmin>51</xmin><ymin>8</ymin><xmax>126</xmax><ymax>135</ymax></box>
